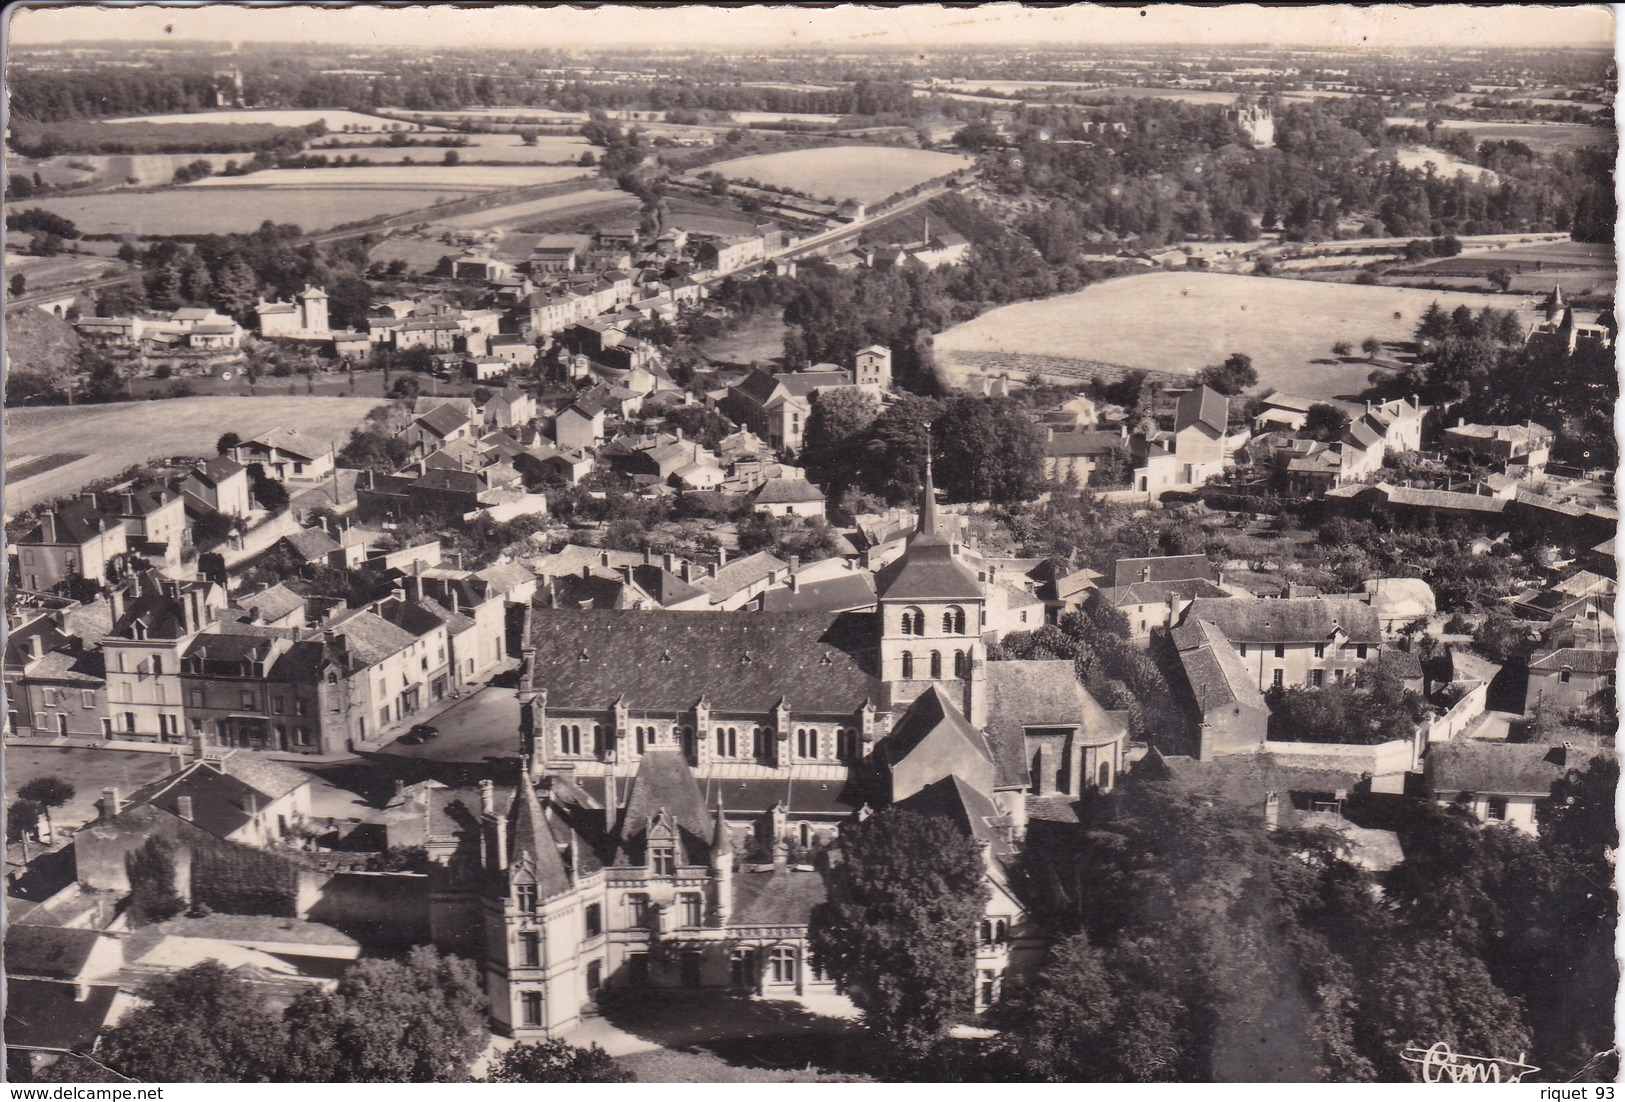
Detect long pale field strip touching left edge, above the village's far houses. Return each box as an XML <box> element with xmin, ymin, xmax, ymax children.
<box><xmin>7</xmin><ymin>187</ymin><xmax>473</xmax><ymax>236</ymax></box>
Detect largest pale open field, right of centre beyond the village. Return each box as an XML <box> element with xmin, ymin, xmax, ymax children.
<box><xmin>934</xmin><ymin>273</ymin><xmax>1534</xmax><ymax>398</ymax></box>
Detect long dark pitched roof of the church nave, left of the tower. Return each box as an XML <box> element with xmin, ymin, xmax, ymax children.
<box><xmin>530</xmin><ymin>610</ymin><xmax>879</xmax><ymax>712</ymax></box>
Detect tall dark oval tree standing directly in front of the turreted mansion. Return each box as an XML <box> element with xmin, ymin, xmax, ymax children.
<box><xmin>809</xmin><ymin>808</ymin><xmax>990</xmax><ymax>1061</ymax></box>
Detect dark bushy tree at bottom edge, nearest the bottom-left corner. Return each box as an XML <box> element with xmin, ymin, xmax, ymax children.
<box><xmin>58</xmin><ymin>961</ymin><xmax>286</xmax><ymax>1082</ymax></box>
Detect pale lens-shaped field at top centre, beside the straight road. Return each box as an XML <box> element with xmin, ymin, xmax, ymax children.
<box><xmin>710</xmin><ymin>145</ymin><xmax>972</xmax><ymax>203</ymax></box>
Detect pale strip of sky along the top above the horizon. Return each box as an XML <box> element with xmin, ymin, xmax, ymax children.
<box><xmin>10</xmin><ymin>3</ymin><xmax>1614</xmax><ymax>52</ymax></box>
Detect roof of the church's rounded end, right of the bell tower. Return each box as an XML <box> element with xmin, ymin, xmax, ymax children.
<box><xmin>986</xmin><ymin>658</ymin><xmax>1126</xmax><ymax>787</ymax></box>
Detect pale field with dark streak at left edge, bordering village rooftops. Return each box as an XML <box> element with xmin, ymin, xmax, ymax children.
<box><xmin>5</xmin><ymin>396</ymin><xmax>379</xmax><ymax>514</ymax></box>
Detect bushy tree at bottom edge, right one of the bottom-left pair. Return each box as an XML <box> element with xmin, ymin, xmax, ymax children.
<box><xmin>286</xmin><ymin>946</ymin><xmax>491</xmax><ymax>1082</ymax></box>
